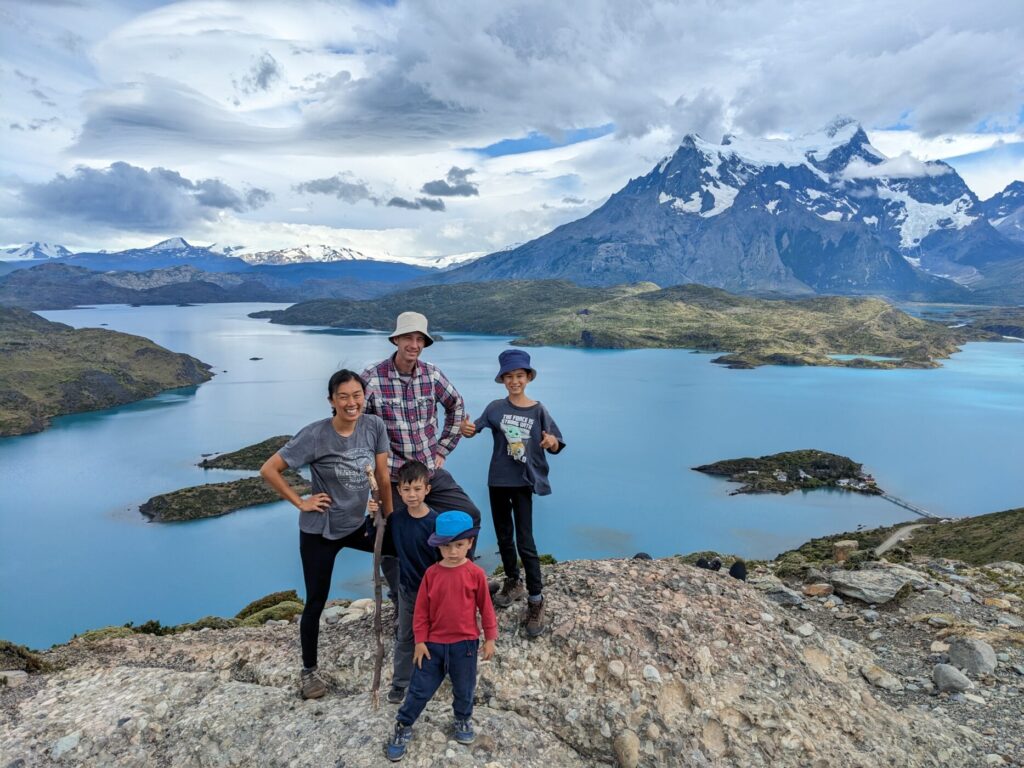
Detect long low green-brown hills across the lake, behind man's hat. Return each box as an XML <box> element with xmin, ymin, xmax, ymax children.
<box><xmin>251</xmin><ymin>281</ymin><xmax>997</xmax><ymax>368</ymax></box>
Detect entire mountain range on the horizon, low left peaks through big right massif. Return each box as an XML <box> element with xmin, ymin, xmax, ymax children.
<box><xmin>8</xmin><ymin>119</ymin><xmax>1024</xmax><ymax>308</ymax></box>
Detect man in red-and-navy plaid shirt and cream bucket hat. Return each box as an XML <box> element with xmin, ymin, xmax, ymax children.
<box><xmin>362</xmin><ymin>312</ymin><xmax>480</xmax><ymax>525</ymax></box>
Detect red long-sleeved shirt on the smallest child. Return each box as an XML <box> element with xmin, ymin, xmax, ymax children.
<box><xmin>413</xmin><ymin>560</ymin><xmax>498</xmax><ymax>643</ymax></box>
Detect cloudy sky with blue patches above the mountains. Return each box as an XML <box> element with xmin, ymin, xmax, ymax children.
<box><xmin>0</xmin><ymin>0</ymin><xmax>1024</xmax><ymax>260</ymax></box>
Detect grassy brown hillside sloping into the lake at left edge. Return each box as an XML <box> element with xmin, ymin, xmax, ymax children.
<box><xmin>0</xmin><ymin>307</ymin><xmax>212</xmax><ymax>436</ymax></box>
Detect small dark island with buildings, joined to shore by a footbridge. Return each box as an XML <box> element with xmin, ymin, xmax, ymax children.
<box><xmin>693</xmin><ymin>450</ymin><xmax>885</xmax><ymax>496</ymax></box>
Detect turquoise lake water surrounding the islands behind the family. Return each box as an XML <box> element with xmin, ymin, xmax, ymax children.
<box><xmin>0</xmin><ymin>304</ymin><xmax>1024</xmax><ymax>647</ymax></box>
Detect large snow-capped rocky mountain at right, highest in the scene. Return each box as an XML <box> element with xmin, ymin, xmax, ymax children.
<box><xmin>441</xmin><ymin>119</ymin><xmax>1024</xmax><ymax>300</ymax></box>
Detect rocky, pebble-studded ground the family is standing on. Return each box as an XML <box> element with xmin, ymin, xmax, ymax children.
<box><xmin>0</xmin><ymin>558</ymin><xmax>1024</xmax><ymax>768</ymax></box>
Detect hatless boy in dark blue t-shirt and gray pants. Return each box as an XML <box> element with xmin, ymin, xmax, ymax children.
<box><xmin>387</xmin><ymin>461</ymin><xmax>440</xmax><ymax>703</ymax></box>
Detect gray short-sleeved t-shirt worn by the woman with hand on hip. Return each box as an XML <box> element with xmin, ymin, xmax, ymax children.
<box><xmin>278</xmin><ymin>414</ymin><xmax>389</xmax><ymax>539</ymax></box>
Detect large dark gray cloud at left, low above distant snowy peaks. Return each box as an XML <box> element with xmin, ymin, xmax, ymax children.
<box><xmin>20</xmin><ymin>163</ymin><xmax>271</xmax><ymax>230</ymax></box>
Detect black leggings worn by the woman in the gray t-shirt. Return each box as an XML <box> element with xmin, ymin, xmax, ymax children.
<box><xmin>299</xmin><ymin>517</ymin><xmax>398</xmax><ymax>669</ymax></box>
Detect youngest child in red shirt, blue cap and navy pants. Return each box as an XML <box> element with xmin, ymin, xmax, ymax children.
<box><xmin>387</xmin><ymin>512</ymin><xmax>498</xmax><ymax>762</ymax></box>
